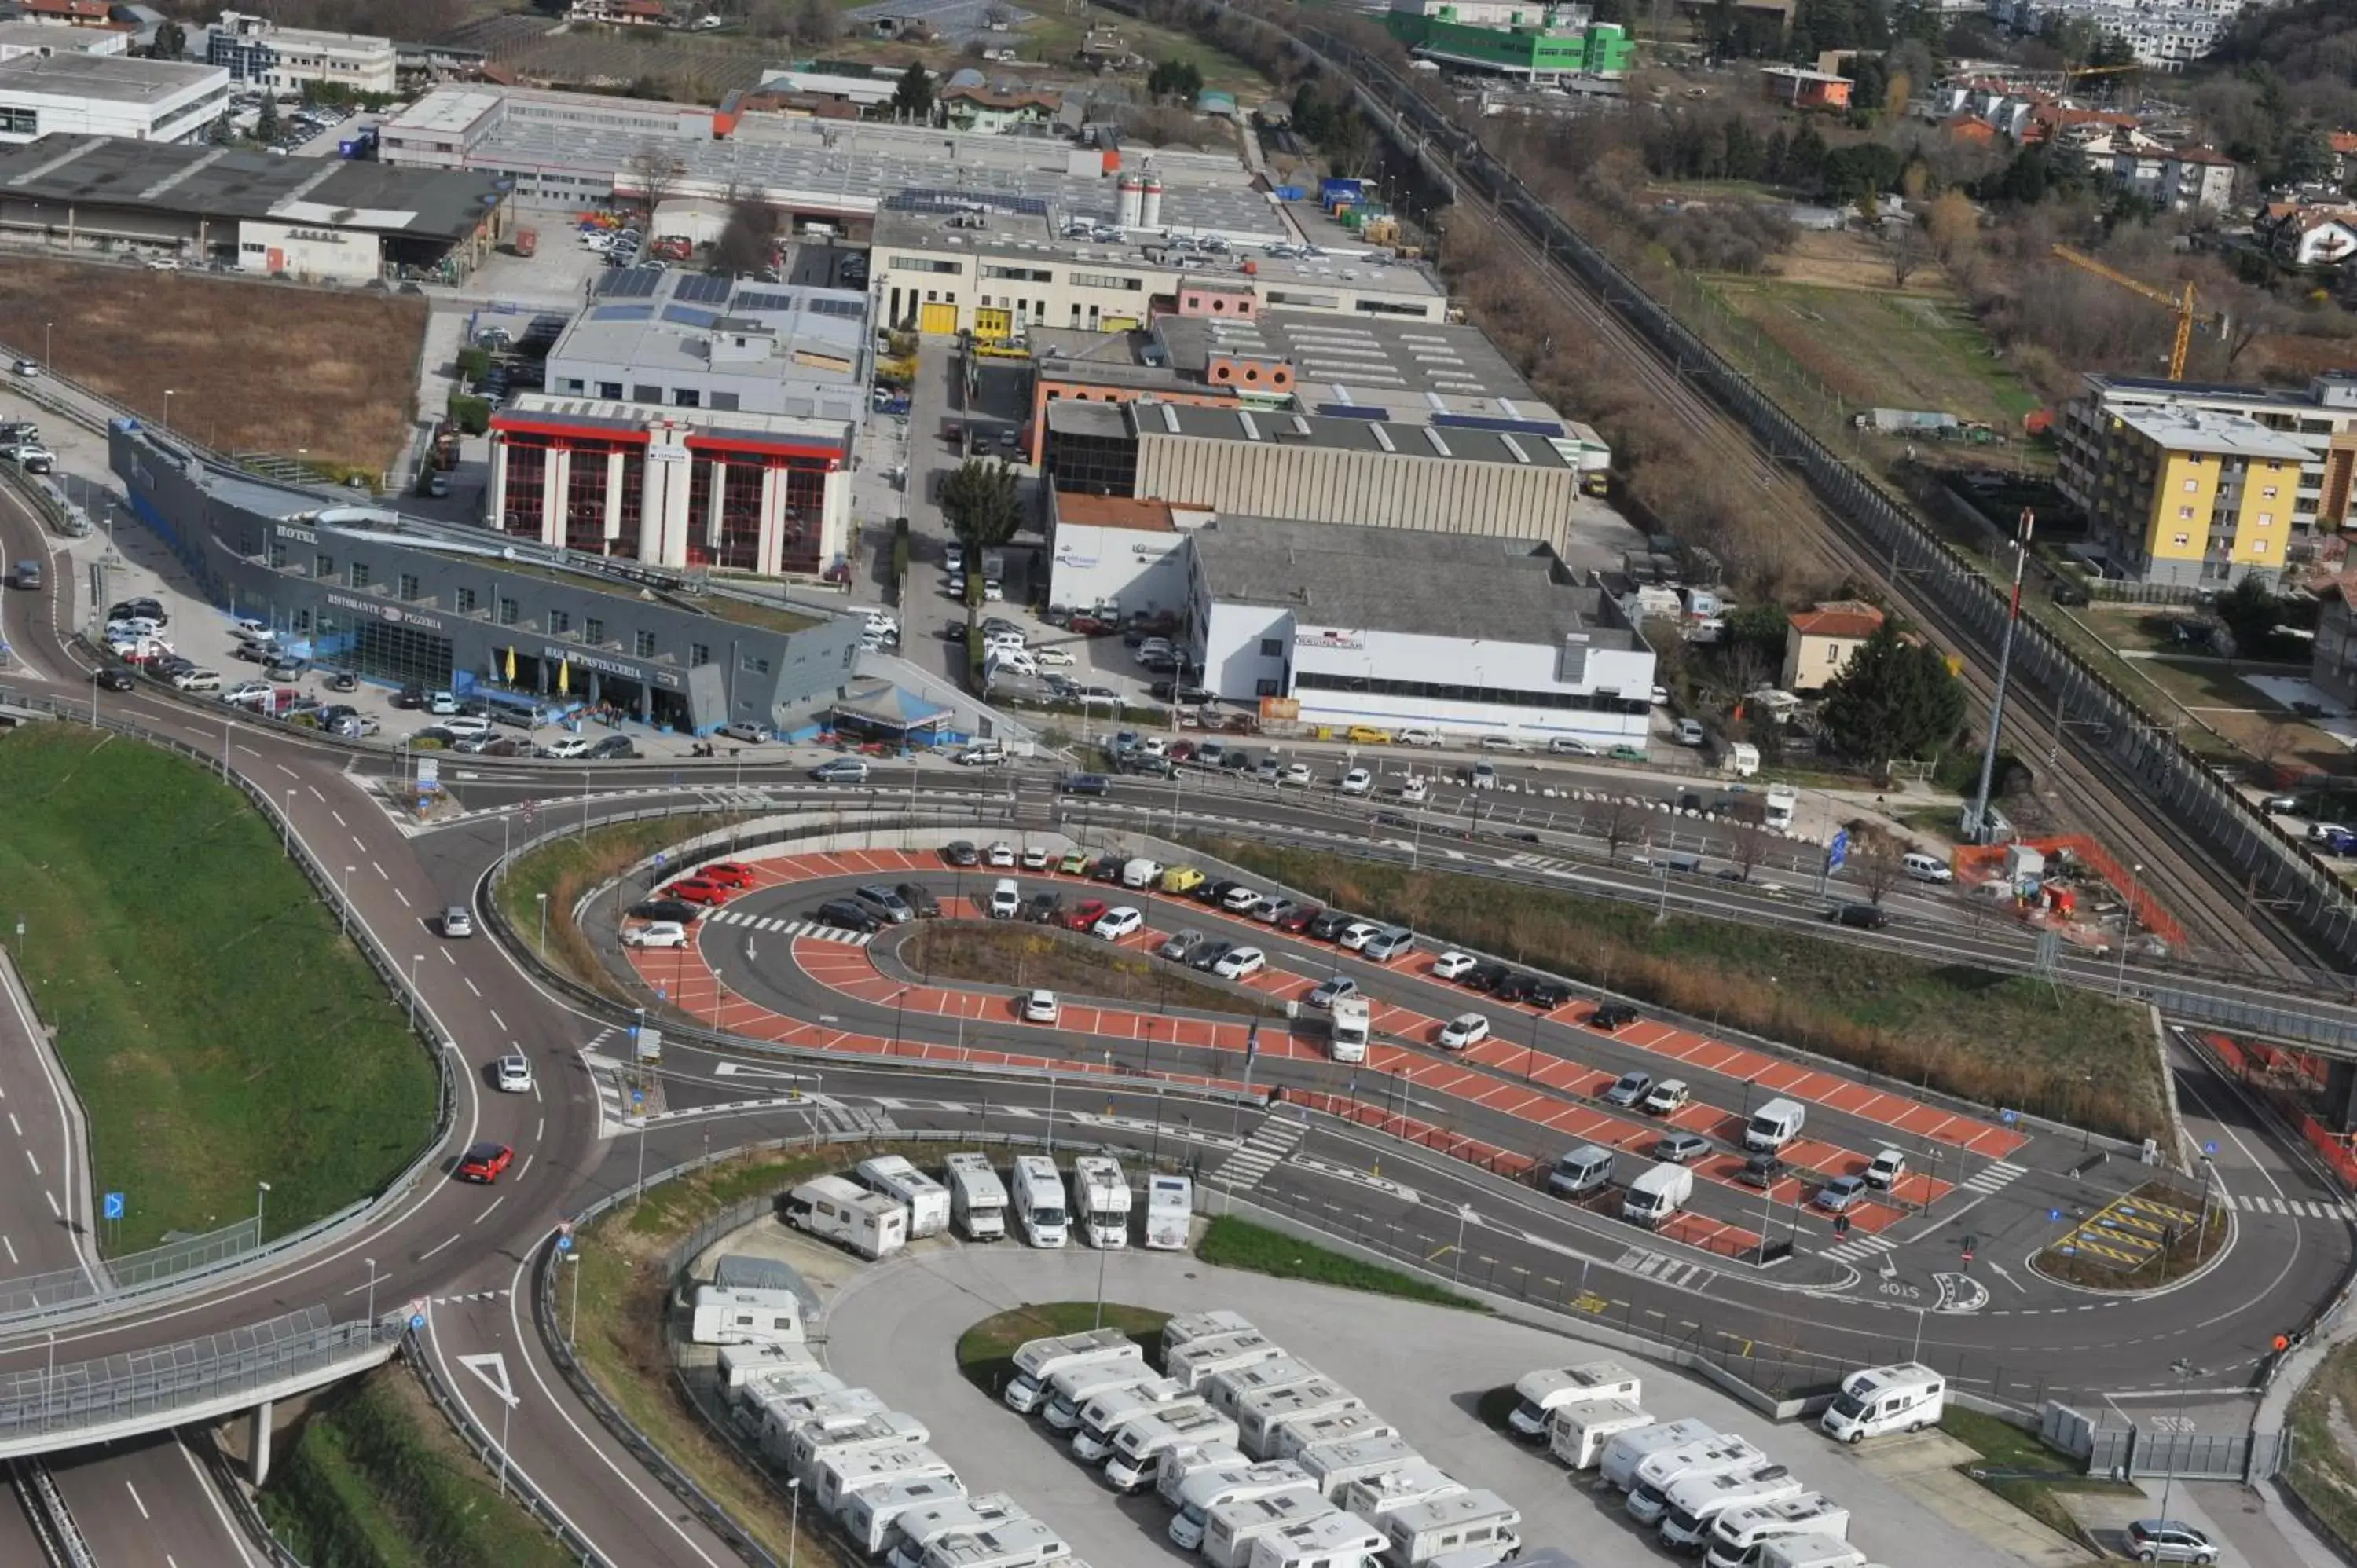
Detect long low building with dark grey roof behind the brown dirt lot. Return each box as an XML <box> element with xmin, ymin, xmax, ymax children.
<box><xmin>0</xmin><ymin>134</ymin><xmax>507</xmax><ymax>283</ymax></box>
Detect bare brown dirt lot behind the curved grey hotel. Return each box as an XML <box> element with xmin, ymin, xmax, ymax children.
<box><xmin>0</xmin><ymin>257</ymin><xmax>427</xmax><ymax>474</ymax></box>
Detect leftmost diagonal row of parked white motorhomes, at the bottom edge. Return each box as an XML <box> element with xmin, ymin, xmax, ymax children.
<box><xmin>719</xmin><ymin>1344</ymin><xmax>1089</xmax><ymax>1568</ymax></box>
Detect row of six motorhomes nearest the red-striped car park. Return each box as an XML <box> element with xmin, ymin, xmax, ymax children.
<box><xmin>778</xmin><ymin>1151</ymin><xmax>1195</xmax><ymax>1259</ymax></box>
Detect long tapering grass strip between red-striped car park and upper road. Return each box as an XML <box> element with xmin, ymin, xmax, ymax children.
<box><xmin>1204</xmin><ymin>840</ymin><xmax>2166</xmax><ymax>1139</ymax></box>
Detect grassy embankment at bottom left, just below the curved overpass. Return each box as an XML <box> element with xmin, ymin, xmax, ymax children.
<box><xmin>262</xmin><ymin>1368</ymin><xmax>573</xmax><ymax>1568</ymax></box>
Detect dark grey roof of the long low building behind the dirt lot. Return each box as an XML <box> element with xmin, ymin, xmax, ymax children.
<box><xmin>0</xmin><ymin>134</ymin><xmax>507</xmax><ymax>240</ymax></box>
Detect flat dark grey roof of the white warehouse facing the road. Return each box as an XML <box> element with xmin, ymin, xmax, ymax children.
<box><xmin>1188</xmin><ymin>516</ymin><xmax>1643</xmax><ymax>648</ymax></box>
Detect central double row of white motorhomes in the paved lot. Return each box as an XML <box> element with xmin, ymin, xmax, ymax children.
<box><xmin>1002</xmin><ymin>1311</ymin><xmax>1523</xmax><ymax>1568</ymax></box>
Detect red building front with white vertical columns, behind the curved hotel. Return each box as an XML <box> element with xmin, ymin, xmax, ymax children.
<box><xmin>488</xmin><ymin>394</ymin><xmax>853</xmax><ymax>577</ymax></box>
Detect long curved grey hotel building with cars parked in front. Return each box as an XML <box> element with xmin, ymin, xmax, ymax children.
<box><xmin>108</xmin><ymin>419</ymin><xmax>865</xmax><ymax>733</ymax></box>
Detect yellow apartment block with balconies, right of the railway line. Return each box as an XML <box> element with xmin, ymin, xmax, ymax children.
<box><xmin>2055</xmin><ymin>372</ymin><xmax>2357</xmax><ymax>587</ymax></box>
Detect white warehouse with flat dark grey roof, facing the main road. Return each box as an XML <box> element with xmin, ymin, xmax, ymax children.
<box><xmin>1186</xmin><ymin>516</ymin><xmax>1655</xmax><ymax>747</ymax></box>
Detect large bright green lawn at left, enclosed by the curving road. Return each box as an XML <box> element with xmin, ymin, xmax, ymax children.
<box><xmin>0</xmin><ymin>724</ymin><xmax>438</xmax><ymax>1252</ymax></box>
